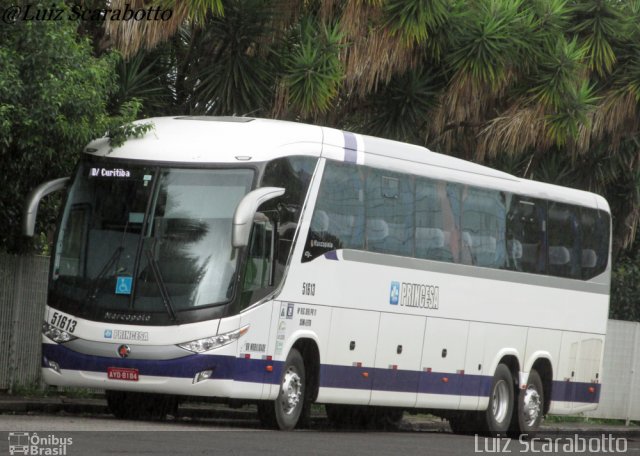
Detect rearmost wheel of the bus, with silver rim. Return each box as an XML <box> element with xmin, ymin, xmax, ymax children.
<box><xmin>511</xmin><ymin>369</ymin><xmax>544</xmax><ymax>438</ymax></box>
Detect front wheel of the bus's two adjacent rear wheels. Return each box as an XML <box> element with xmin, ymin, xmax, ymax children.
<box><xmin>484</xmin><ymin>364</ymin><xmax>514</xmax><ymax>436</ymax></box>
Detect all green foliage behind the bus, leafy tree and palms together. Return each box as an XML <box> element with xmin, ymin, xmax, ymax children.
<box><xmin>6</xmin><ymin>0</ymin><xmax>640</xmax><ymax>324</ymax></box>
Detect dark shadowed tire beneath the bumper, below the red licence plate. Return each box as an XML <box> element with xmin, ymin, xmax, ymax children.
<box><xmin>105</xmin><ymin>390</ymin><xmax>178</xmax><ymax>421</ymax></box>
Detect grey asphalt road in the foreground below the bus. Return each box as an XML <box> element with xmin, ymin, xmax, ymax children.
<box><xmin>0</xmin><ymin>415</ymin><xmax>640</xmax><ymax>456</ymax></box>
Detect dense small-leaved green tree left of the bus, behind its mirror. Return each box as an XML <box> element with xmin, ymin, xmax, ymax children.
<box><xmin>0</xmin><ymin>6</ymin><xmax>138</xmax><ymax>251</ymax></box>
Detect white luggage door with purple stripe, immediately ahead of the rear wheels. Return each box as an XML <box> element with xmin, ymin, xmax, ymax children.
<box><xmin>417</xmin><ymin>317</ymin><xmax>469</xmax><ymax>410</ymax></box>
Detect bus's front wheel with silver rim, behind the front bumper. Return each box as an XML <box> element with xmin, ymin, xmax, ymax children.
<box><xmin>258</xmin><ymin>348</ymin><xmax>308</xmax><ymax>431</ymax></box>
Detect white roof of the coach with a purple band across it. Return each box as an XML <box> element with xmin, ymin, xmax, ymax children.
<box><xmin>85</xmin><ymin>116</ymin><xmax>609</xmax><ymax>212</ymax></box>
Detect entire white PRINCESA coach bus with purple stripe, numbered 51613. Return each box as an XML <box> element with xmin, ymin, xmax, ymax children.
<box><xmin>25</xmin><ymin>117</ymin><xmax>611</xmax><ymax>434</ymax></box>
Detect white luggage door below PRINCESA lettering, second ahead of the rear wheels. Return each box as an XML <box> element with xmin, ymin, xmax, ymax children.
<box><xmin>370</xmin><ymin>313</ymin><xmax>426</xmax><ymax>407</ymax></box>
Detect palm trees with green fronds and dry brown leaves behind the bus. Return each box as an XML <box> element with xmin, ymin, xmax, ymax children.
<box><xmin>107</xmin><ymin>0</ymin><xmax>640</xmax><ymax>251</ymax></box>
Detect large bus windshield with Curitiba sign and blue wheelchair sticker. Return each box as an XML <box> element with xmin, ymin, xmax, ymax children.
<box><xmin>51</xmin><ymin>161</ymin><xmax>254</xmax><ymax>319</ymax></box>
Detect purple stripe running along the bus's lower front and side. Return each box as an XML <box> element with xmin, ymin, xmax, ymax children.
<box><xmin>42</xmin><ymin>344</ymin><xmax>601</xmax><ymax>403</ymax></box>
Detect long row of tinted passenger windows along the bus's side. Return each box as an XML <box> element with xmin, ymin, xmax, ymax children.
<box><xmin>303</xmin><ymin>161</ymin><xmax>610</xmax><ymax>280</ymax></box>
